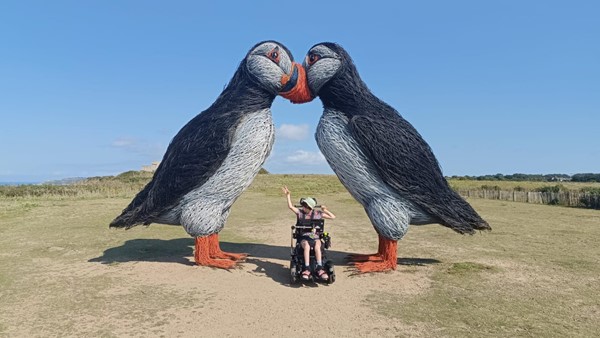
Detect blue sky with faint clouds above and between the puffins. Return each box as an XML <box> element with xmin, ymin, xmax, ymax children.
<box><xmin>0</xmin><ymin>0</ymin><xmax>600</xmax><ymax>182</ymax></box>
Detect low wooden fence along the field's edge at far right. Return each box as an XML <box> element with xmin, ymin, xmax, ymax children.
<box><xmin>457</xmin><ymin>190</ymin><xmax>600</xmax><ymax>210</ymax></box>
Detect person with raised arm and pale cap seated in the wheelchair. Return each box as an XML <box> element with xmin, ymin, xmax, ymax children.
<box><xmin>282</xmin><ymin>186</ymin><xmax>335</xmax><ymax>281</ymax></box>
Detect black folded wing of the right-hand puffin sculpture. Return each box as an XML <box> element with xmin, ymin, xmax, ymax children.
<box><xmin>349</xmin><ymin>112</ymin><xmax>489</xmax><ymax>233</ymax></box>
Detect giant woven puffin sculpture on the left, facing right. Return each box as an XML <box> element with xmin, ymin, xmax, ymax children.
<box><xmin>110</xmin><ymin>41</ymin><xmax>306</xmax><ymax>269</ymax></box>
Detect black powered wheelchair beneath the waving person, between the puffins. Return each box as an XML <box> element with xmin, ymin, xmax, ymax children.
<box><xmin>290</xmin><ymin>207</ymin><xmax>335</xmax><ymax>284</ymax></box>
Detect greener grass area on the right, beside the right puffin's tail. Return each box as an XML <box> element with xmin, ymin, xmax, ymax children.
<box><xmin>360</xmin><ymin>200</ymin><xmax>600</xmax><ymax>337</ymax></box>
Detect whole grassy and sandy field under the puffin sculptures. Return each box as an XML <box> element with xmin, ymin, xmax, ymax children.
<box><xmin>0</xmin><ymin>175</ymin><xmax>600</xmax><ymax>337</ymax></box>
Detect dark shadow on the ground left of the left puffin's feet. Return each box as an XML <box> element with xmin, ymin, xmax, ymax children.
<box><xmin>88</xmin><ymin>238</ymin><xmax>194</xmax><ymax>265</ymax></box>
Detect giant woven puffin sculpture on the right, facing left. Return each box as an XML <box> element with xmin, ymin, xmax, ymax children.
<box><xmin>292</xmin><ymin>43</ymin><xmax>491</xmax><ymax>272</ymax></box>
